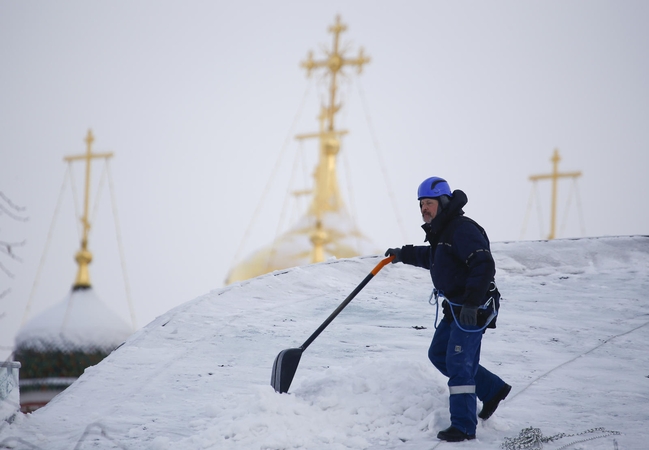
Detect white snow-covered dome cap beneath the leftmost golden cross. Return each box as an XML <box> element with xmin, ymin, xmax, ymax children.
<box><xmin>15</xmin><ymin>288</ymin><xmax>133</xmax><ymax>352</ymax></box>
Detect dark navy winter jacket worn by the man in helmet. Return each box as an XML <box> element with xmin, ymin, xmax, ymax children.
<box><xmin>401</xmin><ymin>190</ymin><xmax>496</xmax><ymax>324</ymax></box>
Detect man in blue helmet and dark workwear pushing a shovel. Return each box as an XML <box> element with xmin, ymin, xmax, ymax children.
<box><xmin>385</xmin><ymin>177</ymin><xmax>511</xmax><ymax>442</ymax></box>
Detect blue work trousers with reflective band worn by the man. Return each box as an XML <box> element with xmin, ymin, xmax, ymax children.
<box><xmin>428</xmin><ymin>320</ymin><xmax>505</xmax><ymax>434</ymax></box>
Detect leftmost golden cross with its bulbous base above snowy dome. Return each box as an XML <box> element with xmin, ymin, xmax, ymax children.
<box><xmin>64</xmin><ymin>129</ymin><xmax>113</xmax><ymax>290</ymax></box>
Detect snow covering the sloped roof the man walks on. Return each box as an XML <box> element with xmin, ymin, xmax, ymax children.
<box><xmin>0</xmin><ymin>236</ymin><xmax>649</xmax><ymax>450</ymax></box>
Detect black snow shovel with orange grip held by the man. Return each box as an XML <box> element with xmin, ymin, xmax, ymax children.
<box><xmin>270</xmin><ymin>256</ymin><xmax>394</xmax><ymax>394</ymax></box>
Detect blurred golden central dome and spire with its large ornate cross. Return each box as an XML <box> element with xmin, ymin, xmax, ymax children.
<box><xmin>226</xmin><ymin>17</ymin><xmax>377</xmax><ymax>284</ymax></box>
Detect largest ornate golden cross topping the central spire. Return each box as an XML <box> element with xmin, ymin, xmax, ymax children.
<box><xmin>301</xmin><ymin>16</ymin><xmax>370</xmax><ymax>131</ymax></box>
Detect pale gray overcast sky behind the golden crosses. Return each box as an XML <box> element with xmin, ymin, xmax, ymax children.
<box><xmin>0</xmin><ymin>0</ymin><xmax>649</xmax><ymax>356</ymax></box>
